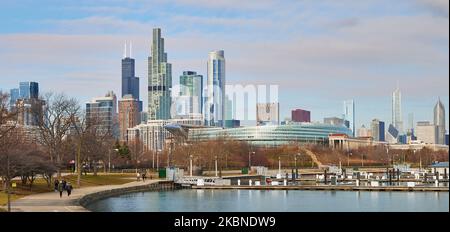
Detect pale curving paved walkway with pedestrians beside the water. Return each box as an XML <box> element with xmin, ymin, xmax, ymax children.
<box><xmin>5</xmin><ymin>180</ymin><xmax>158</xmax><ymax>212</ymax></box>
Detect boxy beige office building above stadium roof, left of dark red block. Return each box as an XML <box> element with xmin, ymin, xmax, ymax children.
<box><xmin>256</xmin><ymin>103</ymin><xmax>280</xmax><ymax>126</ymax></box>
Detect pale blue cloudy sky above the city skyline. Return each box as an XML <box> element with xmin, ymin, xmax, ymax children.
<box><xmin>0</xmin><ymin>0</ymin><xmax>449</xmax><ymax>128</ymax></box>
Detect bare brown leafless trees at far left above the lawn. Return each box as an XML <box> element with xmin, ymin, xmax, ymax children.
<box><xmin>0</xmin><ymin>92</ymin><xmax>141</xmax><ymax>190</ymax></box>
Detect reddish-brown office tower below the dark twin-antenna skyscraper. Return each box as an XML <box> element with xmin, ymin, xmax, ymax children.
<box><xmin>119</xmin><ymin>95</ymin><xmax>141</xmax><ymax>141</ymax></box>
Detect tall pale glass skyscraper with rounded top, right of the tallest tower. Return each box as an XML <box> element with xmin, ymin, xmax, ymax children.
<box><xmin>205</xmin><ymin>50</ymin><xmax>225</xmax><ymax>126</ymax></box>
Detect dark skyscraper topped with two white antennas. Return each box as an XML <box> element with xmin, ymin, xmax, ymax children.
<box><xmin>122</xmin><ymin>44</ymin><xmax>139</xmax><ymax>100</ymax></box>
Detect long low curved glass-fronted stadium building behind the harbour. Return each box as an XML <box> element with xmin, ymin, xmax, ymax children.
<box><xmin>166</xmin><ymin>123</ymin><xmax>352</xmax><ymax>146</ymax></box>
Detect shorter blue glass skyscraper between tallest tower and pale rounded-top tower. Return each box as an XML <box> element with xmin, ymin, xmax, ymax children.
<box><xmin>180</xmin><ymin>71</ymin><xmax>203</xmax><ymax>114</ymax></box>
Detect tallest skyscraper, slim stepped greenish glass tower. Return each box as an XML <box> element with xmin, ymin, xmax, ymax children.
<box><xmin>148</xmin><ymin>28</ymin><xmax>172</xmax><ymax>120</ymax></box>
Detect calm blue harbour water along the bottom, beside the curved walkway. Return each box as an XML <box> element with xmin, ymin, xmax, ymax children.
<box><xmin>87</xmin><ymin>189</ymin><xmax>449</xmax><ymax>212</ymax></box>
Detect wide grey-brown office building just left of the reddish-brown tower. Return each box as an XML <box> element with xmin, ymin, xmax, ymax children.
<box><xmin>86</xmin><ymin>91</ymin><xmax>119</xmax><ymax>138</ymax></box>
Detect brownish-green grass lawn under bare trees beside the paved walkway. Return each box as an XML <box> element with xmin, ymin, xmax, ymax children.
<box><xmin>0</xmin><ymin>173</ymin><xmax>136</xmax><ymax>206</ymax></box>
